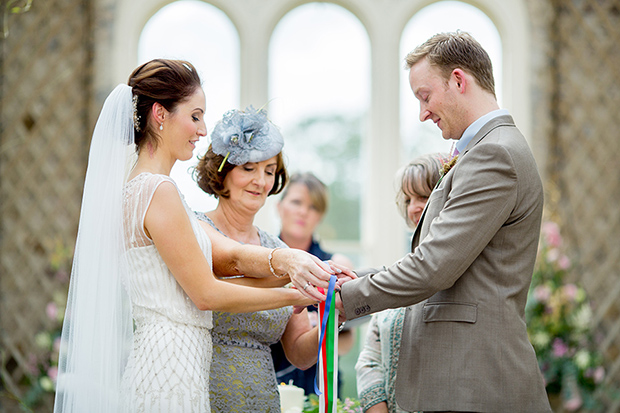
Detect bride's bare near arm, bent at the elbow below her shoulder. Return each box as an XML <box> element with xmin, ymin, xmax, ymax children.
<box><xmin>144</xmin><ymin>182</ymin><xmax>317</xmax><ymax>312</ymax></box>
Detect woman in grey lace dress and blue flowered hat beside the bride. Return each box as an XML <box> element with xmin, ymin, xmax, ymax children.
<box><xmin>195</xmin><ymin>107</ymin><xmax>348</xmax><ymax>412</ymax></box>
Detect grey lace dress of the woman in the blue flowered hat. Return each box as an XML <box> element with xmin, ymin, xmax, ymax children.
<box><xmin>196</xmin><ymin>213</ymin><xmax>293</xmax><ymax>413</ymax></box>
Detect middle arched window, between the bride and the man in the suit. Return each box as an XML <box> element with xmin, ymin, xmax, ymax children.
<box><xmin>269</xmin><ymin>3</ymin><xmax>370</xmax><ymax>259</ymax></box>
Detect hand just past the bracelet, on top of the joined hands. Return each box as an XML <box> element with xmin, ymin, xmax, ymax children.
<box><xmin>272</xmin><ymin>248</ymin><xmax>335</xmax><ymax>302</ymax></box>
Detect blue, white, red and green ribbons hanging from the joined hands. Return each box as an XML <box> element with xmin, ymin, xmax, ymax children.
<box><xmin>314</xmin><ymin>275</ymin><xmax>338</xmax><ymax>413</ymax></box>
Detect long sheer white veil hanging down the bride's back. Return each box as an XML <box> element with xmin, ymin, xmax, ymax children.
<box><xmin>54</xmin><ymin>84</ymin><xmax>134</xmax><ymax>413</ymax></box>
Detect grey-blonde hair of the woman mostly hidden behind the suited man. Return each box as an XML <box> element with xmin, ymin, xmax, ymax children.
<box><xmin>396</xmin><ymin>153</ymin><xmax>445</xmax><ymax>227</ymax></box>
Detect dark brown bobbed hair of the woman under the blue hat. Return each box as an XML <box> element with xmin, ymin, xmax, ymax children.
<box><xmin>193</xmin><ymin>145</ymin><xmax>288</xmax><ymax>198</ymax></box>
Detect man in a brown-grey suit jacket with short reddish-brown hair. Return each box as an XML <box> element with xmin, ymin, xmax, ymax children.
<box><xmin>336</xmin><ymin>32</ymin><xmax>551</xmax><ymax>413</ymax></box>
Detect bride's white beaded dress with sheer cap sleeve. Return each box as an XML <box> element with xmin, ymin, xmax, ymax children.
<box><xmin>121</xmin><ymin>173</ymin><xmax>212</xmax><ymax>413</ymax></box>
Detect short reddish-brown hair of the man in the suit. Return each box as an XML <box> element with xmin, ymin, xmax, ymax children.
<box><xmin>405</xmin><ymin>31</ymin><xmax>495</xmax><ymax>96</ymax></box>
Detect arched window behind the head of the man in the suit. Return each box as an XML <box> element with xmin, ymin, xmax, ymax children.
<box><xmin>400</xmin><ymin>1</ymin><xmax>502</xmax><ymax>164</ymax></box>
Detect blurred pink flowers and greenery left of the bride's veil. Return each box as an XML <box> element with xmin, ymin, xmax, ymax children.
<box><xmin>22</xmin><ymin>243</ymin><xmax>73</xmax><ymax>408</ymax></box>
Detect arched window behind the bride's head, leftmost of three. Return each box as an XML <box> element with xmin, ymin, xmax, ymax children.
<box><xmin>138</xmin><ymin>0</ymin><xmax>239</xmax><ymax>211</ymax></box>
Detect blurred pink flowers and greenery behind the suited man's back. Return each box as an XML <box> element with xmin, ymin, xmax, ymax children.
<box><xmin>525</xmin><ymin>222</ymin><xmax>605</xmax><ymax>411</ymax></box>
